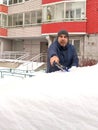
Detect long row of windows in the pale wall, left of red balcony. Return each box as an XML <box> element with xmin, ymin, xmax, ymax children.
<box><xmin>6</xmin><ymin>10</ymin><xmax>42</xmax><ymax>27</ymax></box>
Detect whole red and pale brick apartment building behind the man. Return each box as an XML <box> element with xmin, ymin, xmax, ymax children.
<box><xmin>0</xmin><ymin>0</ymin><xmax>98</xmax><ymax>61</ymax></box>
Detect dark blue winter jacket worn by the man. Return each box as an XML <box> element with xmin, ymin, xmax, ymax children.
<box><xmin>47</xmin><ymin>40</ymin><xmax>78</xmax><ymax>73</ymax></box>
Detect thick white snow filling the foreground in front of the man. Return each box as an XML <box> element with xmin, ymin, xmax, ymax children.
<box><xmin>0</xmin><ymin>64</ymin><xmax>98</xmax><ymax>130</ymax></box>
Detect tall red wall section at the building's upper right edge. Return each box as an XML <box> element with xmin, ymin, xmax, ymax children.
<box><xmin>87</xmin><ymin>0</ymin><xmax>98</xmax><ymax>33</ymax></box>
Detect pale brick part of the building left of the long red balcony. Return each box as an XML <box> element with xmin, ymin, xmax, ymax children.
<box><xmin>0</xmin><ymin>0</ymin><xmax>48</xmax><ymax>58</ymax></box>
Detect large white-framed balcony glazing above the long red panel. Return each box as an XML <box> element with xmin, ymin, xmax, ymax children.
<box><xmin>42</xmin><ymin>1</ymin><xmax>86</xmax><ymax>22</ymax></box>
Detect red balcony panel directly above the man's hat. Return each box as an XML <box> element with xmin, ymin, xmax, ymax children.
<box><xmin>42</xmin><ymin>22</ymin><xmax>86</xmax><ymax>34</ymax></box>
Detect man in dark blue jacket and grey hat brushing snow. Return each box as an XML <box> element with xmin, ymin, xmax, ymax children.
<box><xmin>47</xmin><ymin>30</ymin><xmax>78</xmax><ymax>73</ymax></box>
